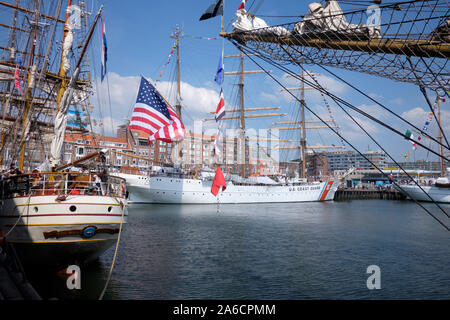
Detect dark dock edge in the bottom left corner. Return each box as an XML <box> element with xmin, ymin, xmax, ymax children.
<box><xmin>0</xmin><ymin>243</ymin><xmax>42</xmax><ymax>300</ymax></box>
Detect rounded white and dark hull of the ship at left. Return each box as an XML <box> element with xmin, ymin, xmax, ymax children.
<box><xmin>0</xmin><ymin>195</ymin><xmax>128</xmax><ymax>267</ymax></box>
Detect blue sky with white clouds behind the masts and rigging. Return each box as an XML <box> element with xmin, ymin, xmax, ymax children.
<box><xmin>79</xmin><ymin>0</ymin><xmax>450</xmax><ymax>161</ymax></box>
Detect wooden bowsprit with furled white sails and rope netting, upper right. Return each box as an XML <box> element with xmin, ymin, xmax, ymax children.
<box><xmin>221</xmin><ymin>0</ymin><xmax>450</xmax><ymax>95</ymax></box>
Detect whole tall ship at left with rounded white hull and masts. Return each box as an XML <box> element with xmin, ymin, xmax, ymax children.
<box><xmin>0</xmin><ymin>0</ymin><xmax>127</xmax><ymax>267</ymax></box>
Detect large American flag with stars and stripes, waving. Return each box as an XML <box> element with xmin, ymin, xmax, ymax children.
<box><xmin>129</xmin><ymin>77</ymin><xmax>186</xmax><ymax>142</ymax></box>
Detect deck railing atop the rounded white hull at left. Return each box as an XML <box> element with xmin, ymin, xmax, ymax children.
<box><xmin>0</xmin><ymin>172</ymin><xmax>127</xmax><ymax>199</ymax></box>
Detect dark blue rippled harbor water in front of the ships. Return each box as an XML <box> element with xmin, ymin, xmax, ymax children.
<box><xmin>28</xmin><ymin>200</ymin><xmax>450</xmax><ymax>300</ymax></box>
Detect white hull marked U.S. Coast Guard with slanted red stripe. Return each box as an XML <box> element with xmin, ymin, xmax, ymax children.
<box><xmin>124</xmin><ymin>177</ymin><xmax>338</xmax><ymax>204</ymax></box>
